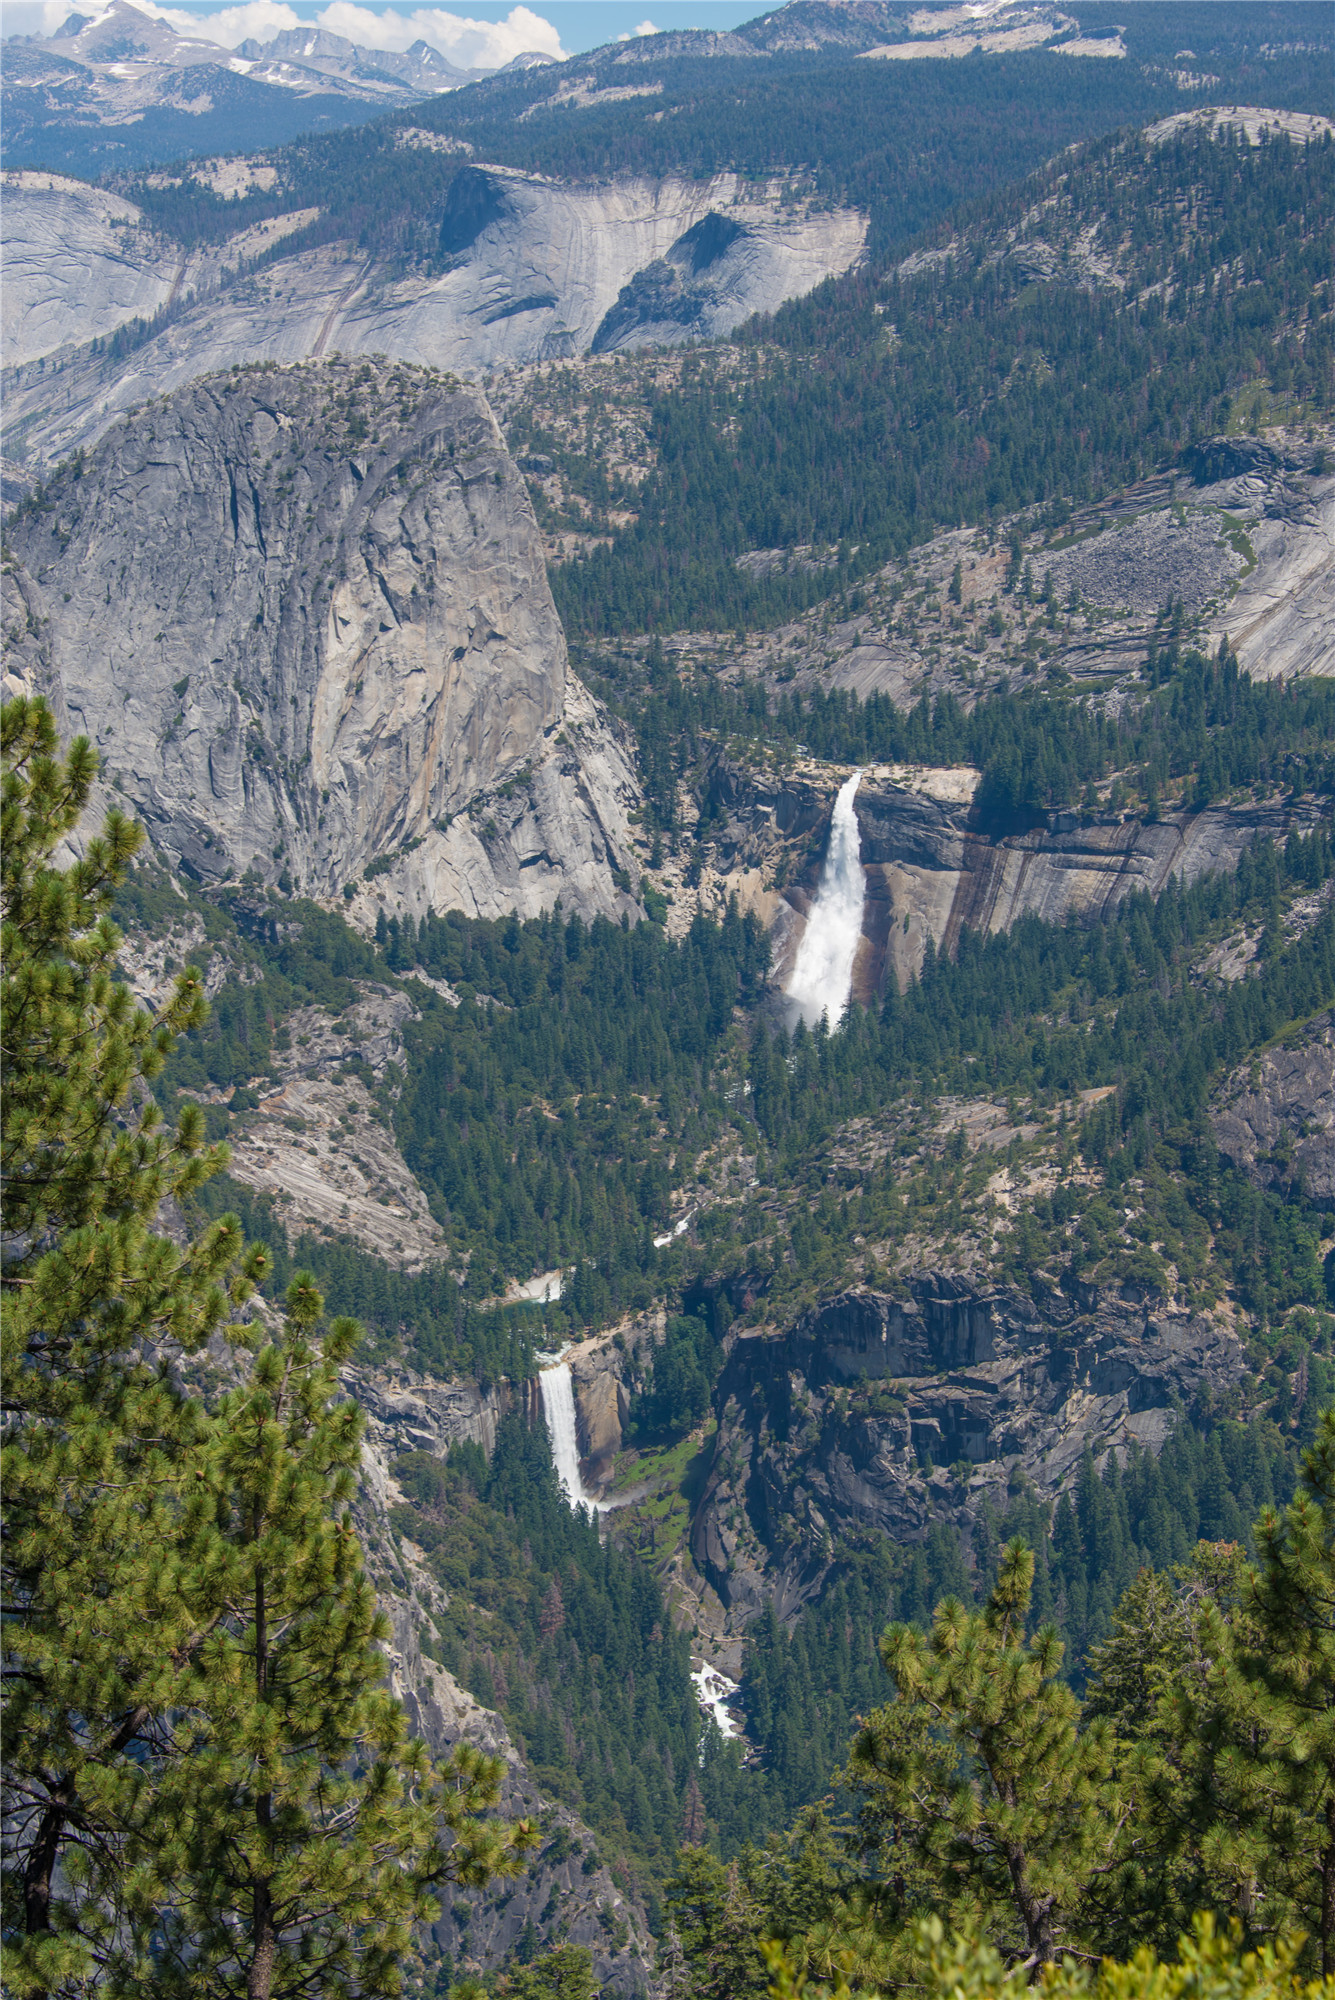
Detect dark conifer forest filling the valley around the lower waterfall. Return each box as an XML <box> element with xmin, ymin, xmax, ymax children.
<box><xmin>122</xmin><ymin>764</ymin><xmax>1335</xmax><ymax>1888</ymax></box>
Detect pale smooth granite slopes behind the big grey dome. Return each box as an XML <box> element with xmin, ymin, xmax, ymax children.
<box><xmin>4</xmin><ymin>166</ymin><xmax>867</xmax><ymax>472</ymax></box>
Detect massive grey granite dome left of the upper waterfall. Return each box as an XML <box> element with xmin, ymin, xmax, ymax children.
<box><xmin>4</xmin><ymin>362</ymin><xmax>638</xmax><ymax>920</ymax></box>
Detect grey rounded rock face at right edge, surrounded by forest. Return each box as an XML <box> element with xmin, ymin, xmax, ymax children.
<box><xmin>1211</xmin><ymin>1012</ymin><xmax>1335</xmax><ymax>1208</ymax></box>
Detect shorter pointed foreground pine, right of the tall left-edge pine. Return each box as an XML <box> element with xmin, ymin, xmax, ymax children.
<box><xmin>127</xmin><ymin>1274</ymin><xmax>534</xmax><ymax>2000</ymax></box>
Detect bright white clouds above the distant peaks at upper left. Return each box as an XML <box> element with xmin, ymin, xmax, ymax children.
<box><xmin>16</xmin><ymin>0</ymin><xmax>567</xmax><ymax>70</ymax></box>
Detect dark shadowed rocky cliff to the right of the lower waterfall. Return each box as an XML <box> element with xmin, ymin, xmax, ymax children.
<box><xmin>691</xmin><ymin>1276</ymin><xmax>1245</xmax><ymax>1622</ymax></box>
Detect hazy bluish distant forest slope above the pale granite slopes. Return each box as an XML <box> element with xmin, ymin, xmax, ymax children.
<box><xmin>124</xmin><ymin>0</ymin><xmax>1329</xmax><ymax>262</ymax></box>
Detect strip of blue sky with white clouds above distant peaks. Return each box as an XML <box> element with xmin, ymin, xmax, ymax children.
<box><xmin>0</xmin><ymin>0</ymin><xmax>767</xmax><ymax>68</ymax></box>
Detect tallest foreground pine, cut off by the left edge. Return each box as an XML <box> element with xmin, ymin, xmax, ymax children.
<box><xmin>0</xmin><ymin>700</ymin><xmax>264</xmax><ymax>1992</ymax></box>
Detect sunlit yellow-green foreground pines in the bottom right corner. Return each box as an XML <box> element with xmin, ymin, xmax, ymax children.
<box><xmin>666</xmin><ymin>1412</ymin><xmax>1335</xmax><ymax>2000</ymax></box>
